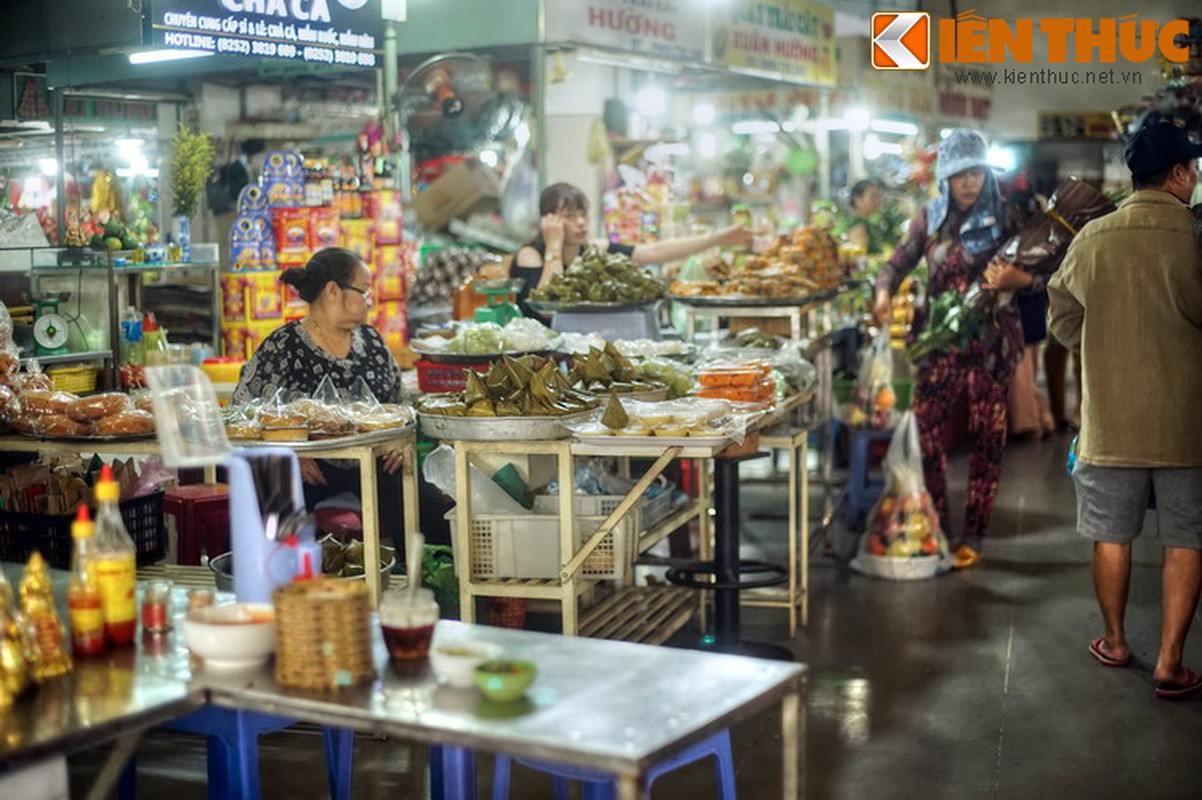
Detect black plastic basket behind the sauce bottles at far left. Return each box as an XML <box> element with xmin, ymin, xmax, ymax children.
<box><xmin>0</xmin><ymin>491</ymin><xmax>167</xmax><ymax>569</ymax></box>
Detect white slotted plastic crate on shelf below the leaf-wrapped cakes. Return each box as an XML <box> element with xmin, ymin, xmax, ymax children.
<box><xmin>447</xmin><ymin>495</ymin><xmax>642</xmax><ymax>580</ymax></box>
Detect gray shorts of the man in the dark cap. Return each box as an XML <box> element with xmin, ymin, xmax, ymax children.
<box><xmin>1072</xmin><ymin>461</ymin><xmax>1202</xmax><ymax>550</ymax></box>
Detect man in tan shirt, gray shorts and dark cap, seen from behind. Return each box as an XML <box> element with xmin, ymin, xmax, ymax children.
<box><xmin>1048</xmin><ymin>121</ymin><xmax>1202</xmax><ymax>698</ymax></box>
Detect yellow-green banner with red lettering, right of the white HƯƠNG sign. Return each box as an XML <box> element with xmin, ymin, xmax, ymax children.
<box><xmin>710</xmin><ymin>0</ymin><xmax>835</xmax><ymax>86</ymax></box>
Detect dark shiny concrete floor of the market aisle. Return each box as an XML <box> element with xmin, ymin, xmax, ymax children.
<box><xmin>71</xmin><ymin>437</ymin><xmax>1202</xmax><ymax>800</ymax></box>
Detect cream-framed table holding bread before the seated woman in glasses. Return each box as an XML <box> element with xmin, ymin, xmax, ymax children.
<box><xmin>0</xmin><ymin>426</ymin><xmax>421</xmax><ymax>602</ymax></box>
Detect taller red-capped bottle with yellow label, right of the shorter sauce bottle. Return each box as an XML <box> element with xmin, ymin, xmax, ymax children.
<box><xmin>93</xmin><ymin>464</ymin><xmax>138</xmax><ymax>646</ymax></box>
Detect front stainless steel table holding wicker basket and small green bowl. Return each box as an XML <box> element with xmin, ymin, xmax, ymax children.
<box><xmin>192</xmin><ymin>621</ymin><xmax>807</xmax><ymax>800</ymax></box>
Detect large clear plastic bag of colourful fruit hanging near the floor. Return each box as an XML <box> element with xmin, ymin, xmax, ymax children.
<box><xmin>851</xmin><ymin>411</ymin><xmax>950</xmax><ymax>580</ymax></box>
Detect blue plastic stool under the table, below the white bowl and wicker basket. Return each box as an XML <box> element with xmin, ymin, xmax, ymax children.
<box><xmin>118</xmin><ymin>705</ymin><xmax>355</xmax><ymax>800</ymax></box>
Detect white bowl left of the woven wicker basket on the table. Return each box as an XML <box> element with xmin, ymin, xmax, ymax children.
<box><xmin>184</xmin><ymin>603</ymin><xmax>275</xmax><ymax>669</ymax></box>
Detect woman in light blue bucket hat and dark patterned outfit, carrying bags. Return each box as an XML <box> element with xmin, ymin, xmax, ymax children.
<box><xmin>873</xmin><ymin>129</ymin><xmax>1031</xmax><ymax>568</ymax></box>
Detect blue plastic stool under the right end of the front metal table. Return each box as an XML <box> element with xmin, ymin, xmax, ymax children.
<box><xmin>493</xmin><ymin>730</ymin><xmax>734</xmax><ymax>800</ymax></box>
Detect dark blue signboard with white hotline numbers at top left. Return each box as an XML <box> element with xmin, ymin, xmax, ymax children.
<box><xmin>150</xmin><ymin>0</ymin><xmax>383</xmax><ymax>67</ymax></box>
